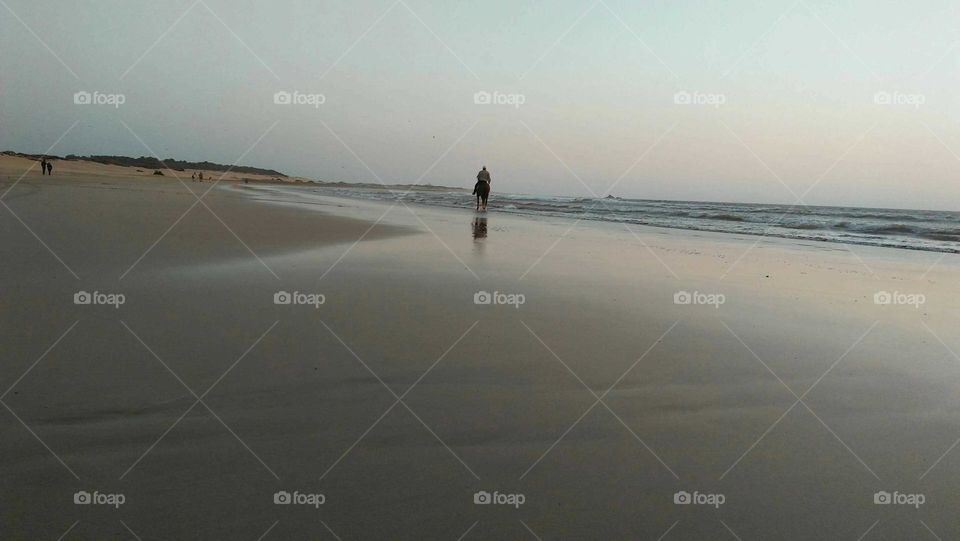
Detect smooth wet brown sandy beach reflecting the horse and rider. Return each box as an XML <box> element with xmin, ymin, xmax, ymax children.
<box><xmin>0</xmin><ymin>162</ymin><xmax>960</xmax><ymax>540</ymax></box>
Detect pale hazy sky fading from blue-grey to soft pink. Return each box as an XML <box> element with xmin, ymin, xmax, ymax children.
<box><xmin>0</xmin><ymin>0</ymin><xmax>960</xmax><ymax>210</ymax></box>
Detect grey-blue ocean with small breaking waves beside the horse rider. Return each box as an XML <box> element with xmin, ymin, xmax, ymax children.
<box><xmin>249</xmin><ymin>184</ymin><xmax>960</xmax><ymax>253</ymax></box>
